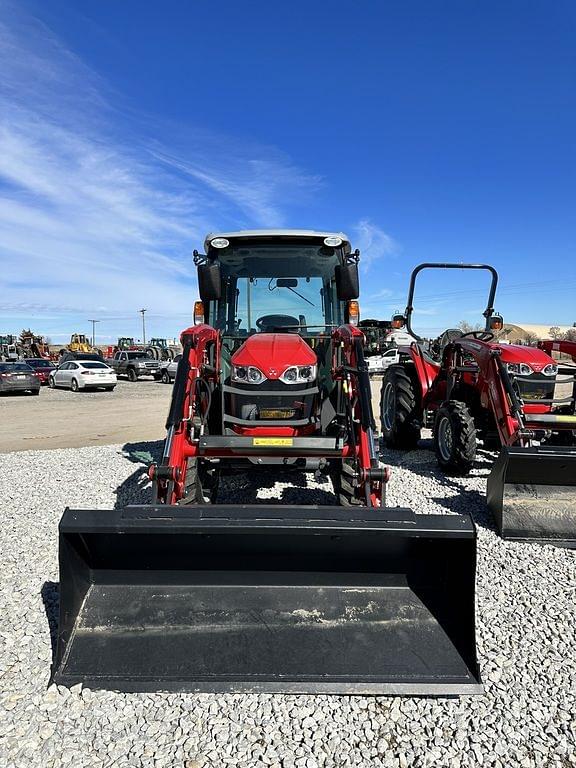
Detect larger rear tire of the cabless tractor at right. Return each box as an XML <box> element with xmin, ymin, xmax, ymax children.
<box><xmin>380</xmin><ymin>365</ymin><xmax>422</xmax><ymax>450</ymax></box>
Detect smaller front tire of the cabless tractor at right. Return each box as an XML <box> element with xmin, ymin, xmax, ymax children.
<box><xmin>434</xmin><ymin>400</ymin><xmax>476</xmax><ymax>475</ymax></box>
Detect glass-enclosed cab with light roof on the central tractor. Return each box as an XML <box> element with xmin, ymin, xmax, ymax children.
<box><xmin>195</xmin><ymin>231</ymin><xmax>358</xmax><ymax>339</ymax></box>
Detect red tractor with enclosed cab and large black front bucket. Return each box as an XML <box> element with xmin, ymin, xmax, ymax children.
<box><xmin>54</xmin><ymin>230</ymin><xmax>482</xmax><ymax>695</ymax></box>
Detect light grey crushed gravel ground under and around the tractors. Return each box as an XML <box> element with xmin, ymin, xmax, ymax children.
<box><xmin>0</xmin><ymin>436</ymin><xmax>576</xmax><ymax>768</ymax></box>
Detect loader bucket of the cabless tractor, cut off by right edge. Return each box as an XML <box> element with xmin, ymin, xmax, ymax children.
<box><xmin>487</xmin><ymin>446</ymin><xmax>576</xmax><ymax>547</ymax></box>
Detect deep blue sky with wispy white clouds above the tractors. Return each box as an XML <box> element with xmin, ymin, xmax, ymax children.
<box><xmin>0</xmin><ymin>0</ymin><xmax>576</xmax><ymax>342</ymax></box>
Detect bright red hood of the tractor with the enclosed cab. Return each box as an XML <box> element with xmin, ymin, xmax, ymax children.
<box><xmin>231</xmin><ymin>333</ymin><xmax>316</xmax><ymax>380</ymax></box>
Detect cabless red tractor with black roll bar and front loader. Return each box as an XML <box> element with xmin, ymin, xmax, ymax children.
<box><xmin>380</xmin><ymin>264</ymin><xmax>576</xmax><ymax>546</ymax></box>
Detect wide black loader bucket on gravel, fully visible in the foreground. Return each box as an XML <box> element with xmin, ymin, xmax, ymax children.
<box><xmin>53</xmin><ymin>505</ymin><xmax>482</xmax><ymax>695</ymax></box>
